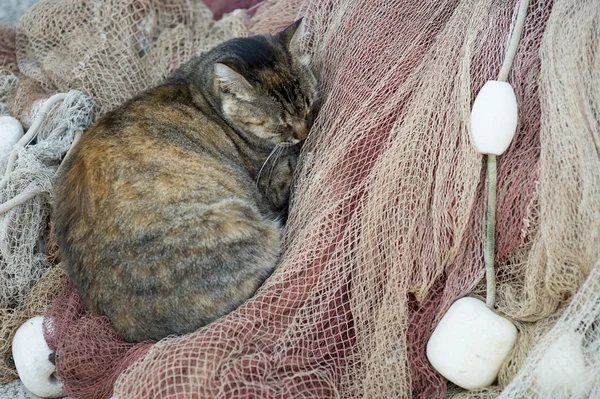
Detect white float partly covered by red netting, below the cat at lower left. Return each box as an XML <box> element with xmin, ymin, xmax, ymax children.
<box><xmin>12</xmin><ymin>316</ymin><xmax>65</xmax><ymax>398</ymax></box>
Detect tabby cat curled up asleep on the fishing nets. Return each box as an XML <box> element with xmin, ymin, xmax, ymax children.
<box><xmin>54</xmin><ymin>20</ymin><xmax>318</xmax><ymax>342</ymax></box>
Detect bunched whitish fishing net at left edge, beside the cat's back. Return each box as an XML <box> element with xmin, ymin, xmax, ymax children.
<box><xmin>0</xmin><ymin>89</ymin><xmax>92</xmax><ymax>307</ymax></box>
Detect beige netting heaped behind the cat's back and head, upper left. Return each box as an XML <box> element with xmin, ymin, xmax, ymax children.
<box><xmin>17</xmin><ymin>0</ymin><xmax>246</xmax><ymax>114</ymax></box>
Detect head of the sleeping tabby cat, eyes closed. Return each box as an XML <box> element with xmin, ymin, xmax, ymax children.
<box><xmin>212</xmin><ymin>20</ymin><xmax>318</xmax><ymax>146</ymax></box>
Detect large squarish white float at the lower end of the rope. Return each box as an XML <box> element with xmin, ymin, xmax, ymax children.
<box><xmin>427</xmin><ymin>298</ymin><xmax>517</xmax><ymax>389</ymax></box>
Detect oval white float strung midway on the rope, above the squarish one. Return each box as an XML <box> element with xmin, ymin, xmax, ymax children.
<box><xmin>471</xmin><ymin>80</ymin><xmax>517</xmax><ymax>155</ymax></box>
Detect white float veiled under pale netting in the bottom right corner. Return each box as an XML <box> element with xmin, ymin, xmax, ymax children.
<box><xmin>535</xmin><ymin>332</ymin><xmax>591</xmax><ymax>398</ymax></box>
